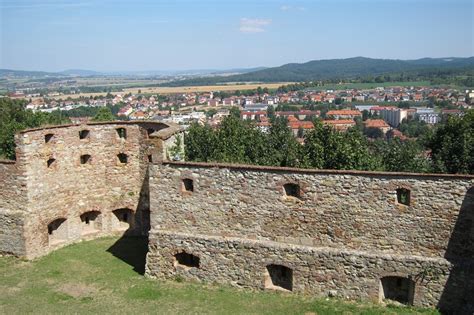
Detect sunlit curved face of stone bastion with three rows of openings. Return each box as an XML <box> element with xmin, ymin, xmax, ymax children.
<box><xmin>17</xmin><ymin>123</ymin><xmax>152</xmax><ymax>257</ymax></box>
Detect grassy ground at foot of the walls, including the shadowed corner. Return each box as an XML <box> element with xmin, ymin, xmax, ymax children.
<box><xmin>0</xmin><ymin>238</ymin><xmax>437</xmax><ymax>314</ymax></box>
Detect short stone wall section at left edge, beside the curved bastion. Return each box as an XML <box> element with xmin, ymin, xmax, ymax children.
<box><xmin>0</xmin><ymin>160</ymin><xmax>26</xmax><ymax>256</ymax></box>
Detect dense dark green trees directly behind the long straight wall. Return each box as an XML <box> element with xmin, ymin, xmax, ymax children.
<box><xmin>185</xmin><ymin>110</ymin><xmax>474</xmax><ymax>174</ymax></box>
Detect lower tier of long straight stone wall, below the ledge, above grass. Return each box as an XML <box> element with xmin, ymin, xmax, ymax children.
<box><xmin>146</xmin><ymin>230</ymin><xmax>466</xmax><ymax>309</ymax></box>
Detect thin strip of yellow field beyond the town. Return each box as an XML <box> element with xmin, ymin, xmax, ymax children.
<box><xmin>39</xmin><ymin>82</ymin><xmax>291</xmax><ymax>100</ymax></box>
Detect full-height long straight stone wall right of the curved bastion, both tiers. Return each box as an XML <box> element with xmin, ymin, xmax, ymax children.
<box><xmin>147</xmin><ymin>162</ymin><xmax>474</xmax><ymax>309</ymax></box>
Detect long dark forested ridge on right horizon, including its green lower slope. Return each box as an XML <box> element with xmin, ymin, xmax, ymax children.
<box><xmin>162</xmin><ymin>57</ymin><xmax>474</xmax><ymax>86</ymax></box>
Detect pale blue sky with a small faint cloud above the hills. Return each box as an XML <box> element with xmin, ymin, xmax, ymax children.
<box><xmin>0</xmin><ymin>0</ymin><xmax>474</xmax><ymax>71</ymax></box>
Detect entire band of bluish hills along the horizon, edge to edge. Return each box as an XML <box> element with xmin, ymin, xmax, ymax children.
<box><xmin>0</xmin><ymin>57</ymin><xmax>474</xmax><ymax>86</ymax></box>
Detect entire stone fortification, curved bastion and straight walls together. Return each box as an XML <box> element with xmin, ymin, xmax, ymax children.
<box><xmin>0</xmin><ymin>122</ymin><xmax>474</xmax><ymax>314</ymax></box>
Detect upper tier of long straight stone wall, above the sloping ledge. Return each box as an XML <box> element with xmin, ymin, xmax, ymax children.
<box><xmin>150</xmin><ymin>162</ymin><xmax>474</xmax><ymax>259</ymax></box>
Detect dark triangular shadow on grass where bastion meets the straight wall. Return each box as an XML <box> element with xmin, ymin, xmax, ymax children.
<box><xmin>107</xmin><ymin>236</ymin><xmax>148</xmax><ymax>275</ymax></box>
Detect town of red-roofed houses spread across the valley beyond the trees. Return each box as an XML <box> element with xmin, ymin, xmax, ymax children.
<box><xmin>23</xmin><ymin>87</ymin><xmax>474</xmax><ymax>141</ymax></box>
